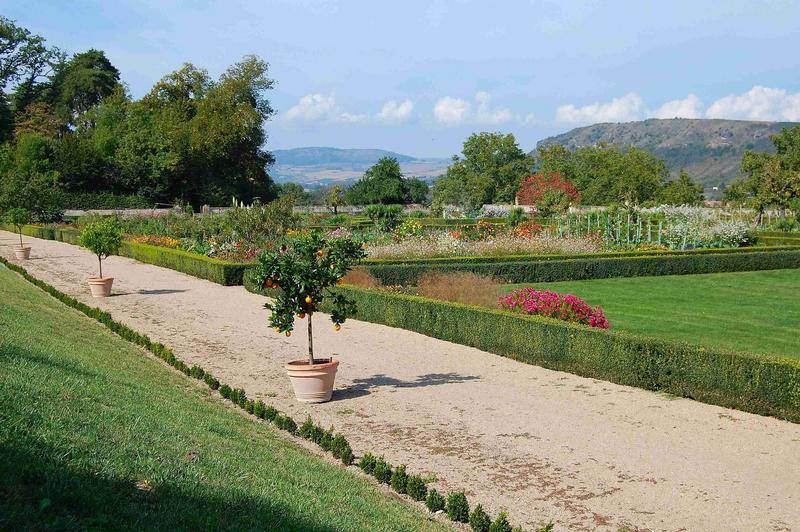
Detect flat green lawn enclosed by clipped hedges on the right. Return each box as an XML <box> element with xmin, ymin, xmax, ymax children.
<box><xmin>501</xmin><ymin>270</ymin><xmax>800</xmax><ymax>359</ymax></box>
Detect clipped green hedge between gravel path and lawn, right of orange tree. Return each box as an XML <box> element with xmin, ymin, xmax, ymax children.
<box><xmin>244</xmin><ymin>272</ymin><xmax>800</xmax><ymax>423</ymax></box>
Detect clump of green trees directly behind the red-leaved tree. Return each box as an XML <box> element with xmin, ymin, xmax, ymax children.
<box><xmin>433</xmin><ymin>133</ymin><xmax>703</xmax><ymax>213</ymax></box>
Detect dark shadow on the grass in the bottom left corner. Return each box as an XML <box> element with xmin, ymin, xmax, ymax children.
<box><xmin>0</xmin><ymin>438</ymin><xmax>334</xmax><ymax>532</ymax></box>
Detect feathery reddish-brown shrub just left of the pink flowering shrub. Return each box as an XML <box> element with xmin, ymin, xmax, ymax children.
<box><xmin>417</xmin><ymin>271</ymin><xmax>497</xmax><ymax>307</ymax></box>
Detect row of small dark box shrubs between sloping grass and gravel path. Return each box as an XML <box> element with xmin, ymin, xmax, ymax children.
<box><xmin>0</xmin><ymin>257</ymin><xmax>540</xmax><ymax>531</ymax></box>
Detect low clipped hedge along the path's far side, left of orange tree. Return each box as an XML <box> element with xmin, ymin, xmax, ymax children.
<box><xmin>0</xmin><ymin>225</ymin><xmax>247</xmax><ymax>286</ymax></box>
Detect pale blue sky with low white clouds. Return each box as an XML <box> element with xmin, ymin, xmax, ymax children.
<box><xmin>6</xmin><ymin>0</ymin><xmax>800</xmax><ymax>157</ymax></box>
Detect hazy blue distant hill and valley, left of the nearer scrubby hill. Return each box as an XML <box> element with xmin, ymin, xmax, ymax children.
<box><xmin>269</xmin><ymin>147</ymin><xmax>450</xmax><ymax>186</ymax></box>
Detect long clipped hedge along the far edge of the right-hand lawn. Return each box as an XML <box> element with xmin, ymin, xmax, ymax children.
<box><xmin>360</xmin><ymin>247</ymin><xmax>800</xmax><ymax>286</ymax></box>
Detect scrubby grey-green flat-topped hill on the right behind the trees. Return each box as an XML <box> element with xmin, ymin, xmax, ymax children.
<box><xmin>537</xmin><ymin>118</ymin><xmax>797</xmax><ymax>188</ymax></box>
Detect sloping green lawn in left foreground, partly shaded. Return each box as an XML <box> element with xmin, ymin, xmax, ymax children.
<box><xmin>0</xmin><ymin>265</ymin><xmax>440</xmax><ymax>531</ymax></box>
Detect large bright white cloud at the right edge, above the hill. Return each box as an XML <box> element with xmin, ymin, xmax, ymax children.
<box><xmin>706</xmin><ymin>85</ymin><xmax>800</xmax><ymax>121</ymax></box>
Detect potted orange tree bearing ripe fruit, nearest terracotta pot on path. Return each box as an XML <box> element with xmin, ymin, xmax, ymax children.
<box><xmin>256</xmin><ymin>233</ymin><xmax>366</xmax><ymax>403</ymax></box>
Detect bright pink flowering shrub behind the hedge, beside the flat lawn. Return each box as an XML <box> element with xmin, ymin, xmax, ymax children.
<box><xmin>499</xmin><ymin>288</ymin><xmax>610</xmax><ymax>329</ymax></box>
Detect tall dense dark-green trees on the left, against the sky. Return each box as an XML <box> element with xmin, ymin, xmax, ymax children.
<box><xmin>0</xmin><ymin>17</ymin><xmax>277</xmax><ymax>217</ymax></box>
